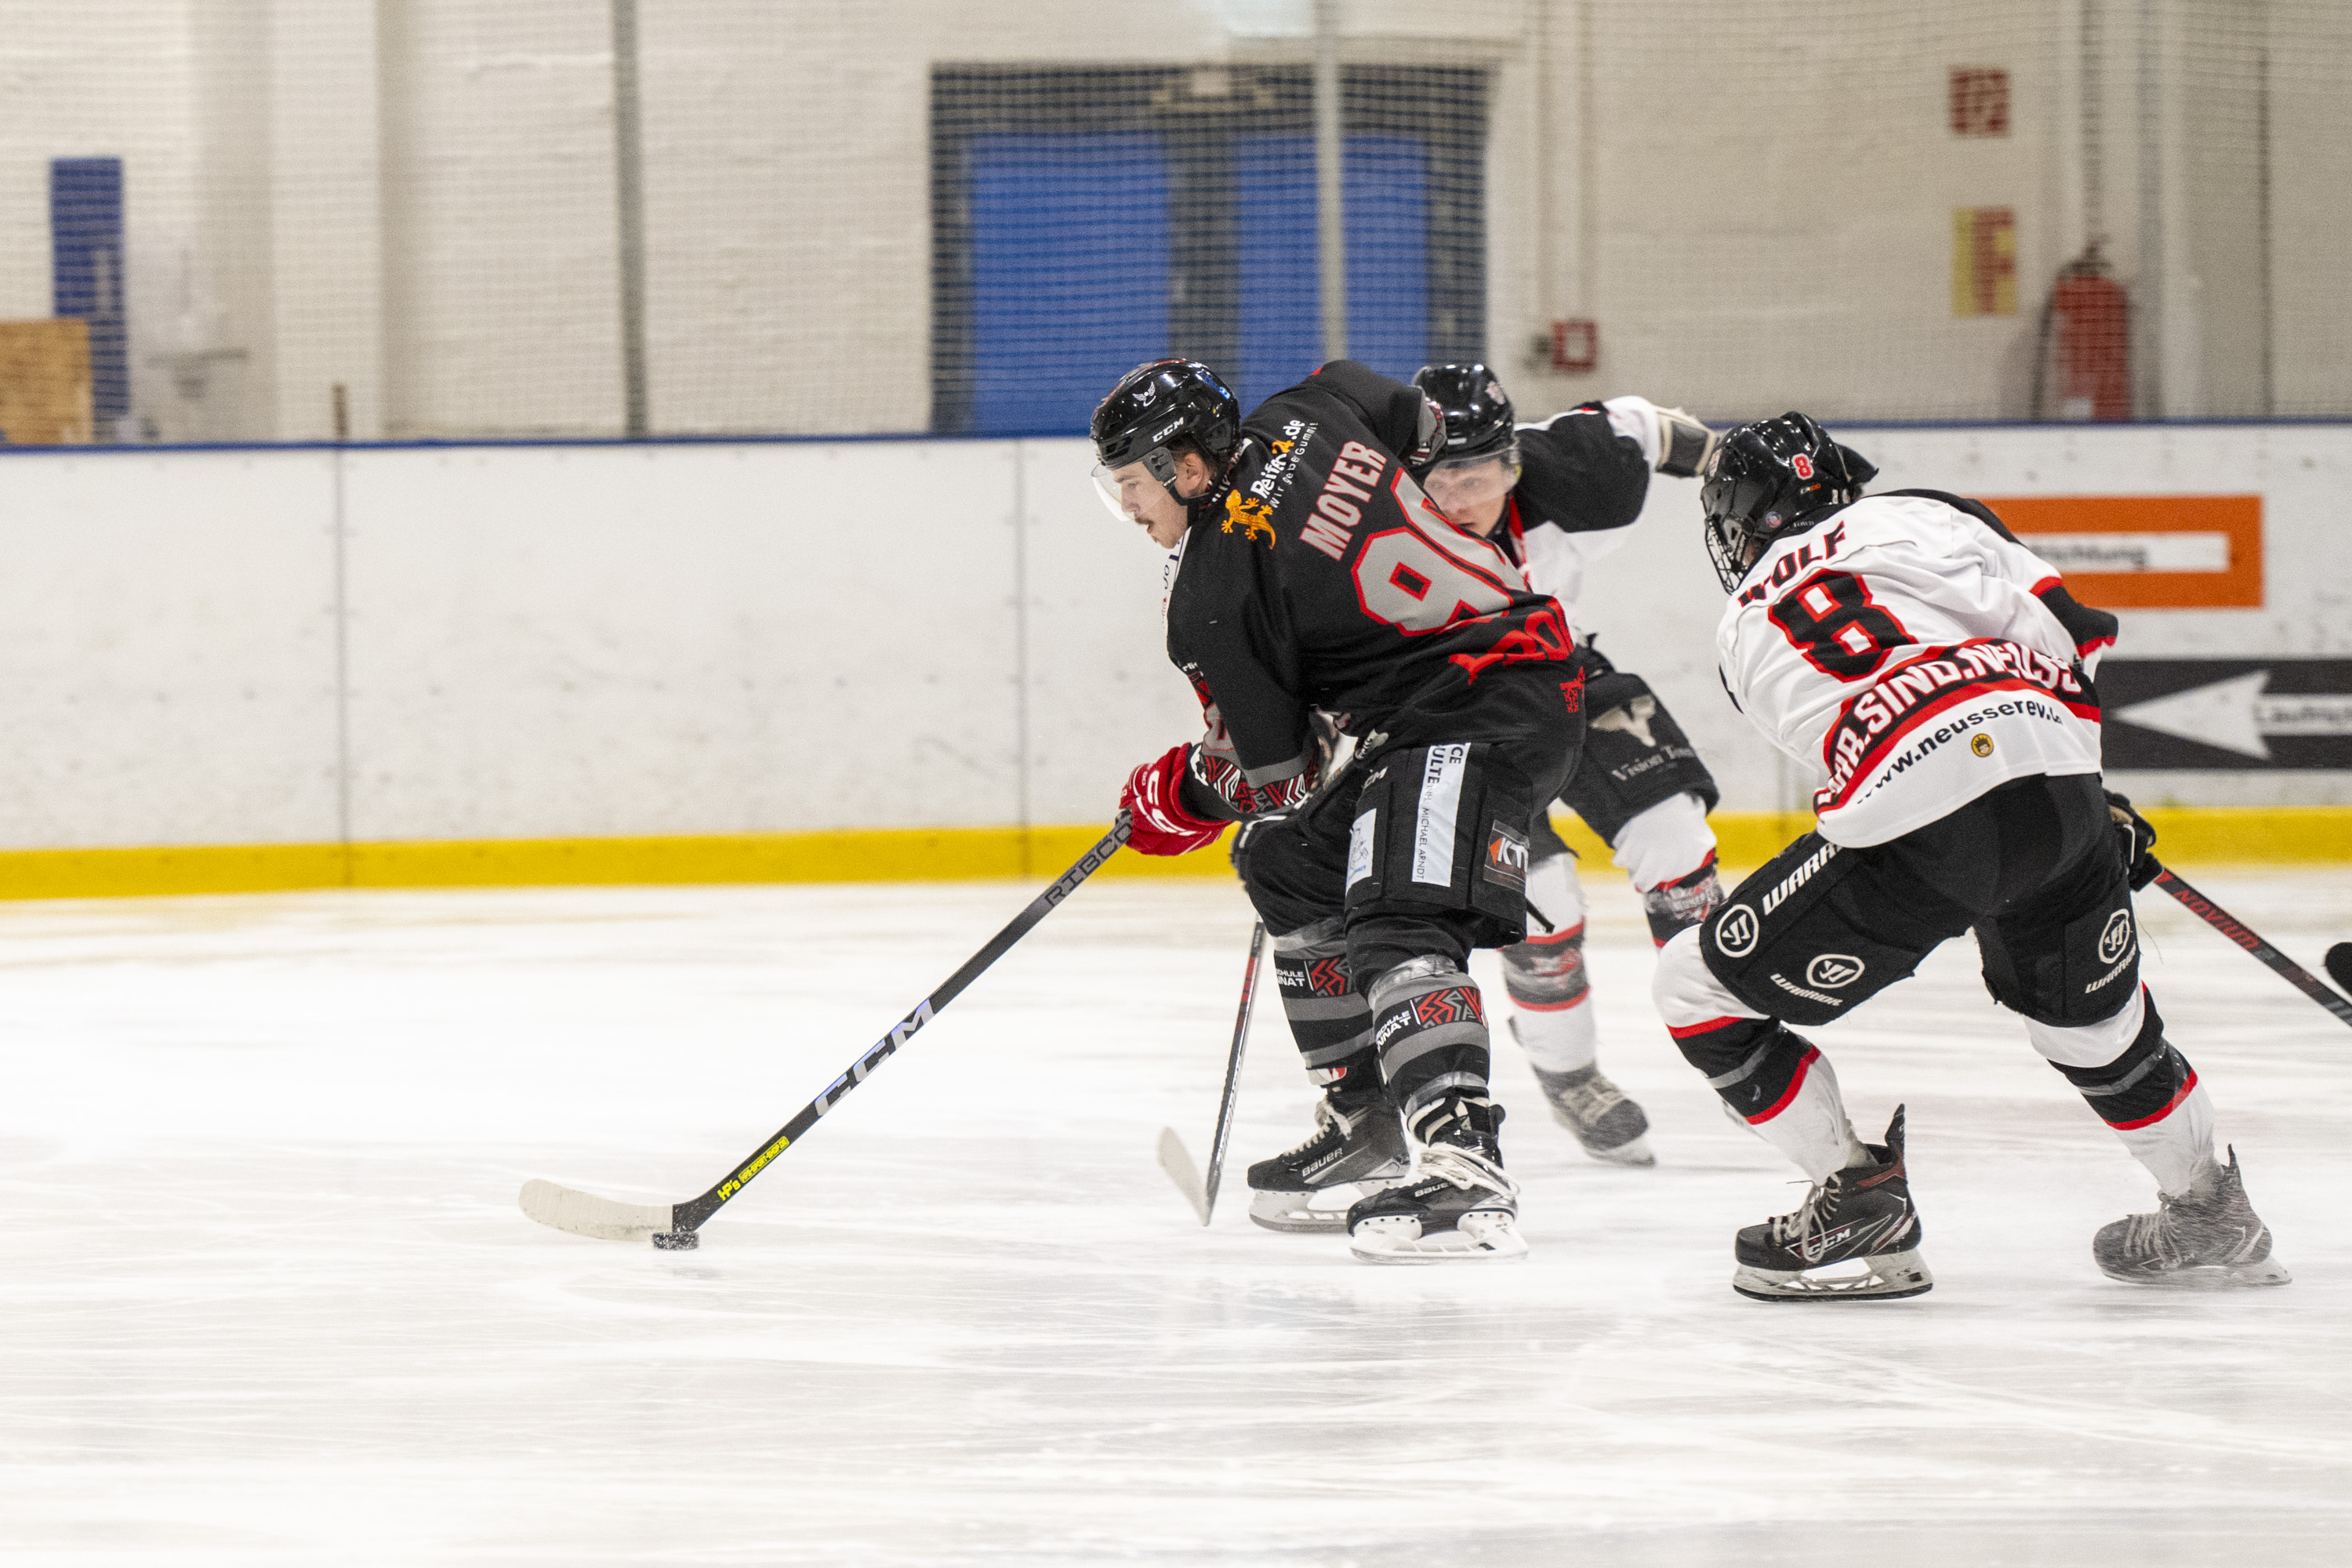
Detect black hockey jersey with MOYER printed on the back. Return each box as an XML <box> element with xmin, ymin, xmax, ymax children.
<box><xmin>1167</xmin><ymin>360</ymin><xmax>1573</xmax><ymax>815</ymax></box>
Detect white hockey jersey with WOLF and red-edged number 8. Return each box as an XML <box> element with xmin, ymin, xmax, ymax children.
<box><xmin>1715</xmin><ymin>492</ymin><xmax>2117</xmax><ymax>848</ymax></box>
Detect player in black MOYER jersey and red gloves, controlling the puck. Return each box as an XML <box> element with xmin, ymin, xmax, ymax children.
<box><xmin>1094</xmin><ymin>360</ymin><xmax>1583</xmax><ymax>1262</ymax></box>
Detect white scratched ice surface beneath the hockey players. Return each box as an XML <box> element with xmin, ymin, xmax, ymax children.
<box><xmin>0</xmin><ymin>872</ymin><xmax>2352</xmax><ymax>1568</ymax></box>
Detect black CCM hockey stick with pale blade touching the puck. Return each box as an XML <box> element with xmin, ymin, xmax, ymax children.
<box><xmin>520</xmin><ymin>811</ymin><xmax>1129</xmax><ymax>1253</ymax></box>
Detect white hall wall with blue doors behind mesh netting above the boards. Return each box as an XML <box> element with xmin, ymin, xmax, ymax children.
<box><xmin>0</xmin><ymin>0</ymin><xmax>2352</xmax><ymax>442</ymax></box>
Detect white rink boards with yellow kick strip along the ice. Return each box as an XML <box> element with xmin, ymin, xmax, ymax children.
<box><xmin>0</xmin><ymin>426</ymin><xmax>2352</xmax><ymax>895</ymax></box>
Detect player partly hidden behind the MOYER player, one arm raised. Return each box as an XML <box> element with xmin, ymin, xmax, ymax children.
<box><xmin>1414</xmin><ymin>365</ymin><xmax>1724</xmax><ymax>1166</ymax></box>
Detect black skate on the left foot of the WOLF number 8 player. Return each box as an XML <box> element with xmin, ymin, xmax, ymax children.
<box><xmin>1731</xmin><ymin>1105</ymin><xmax>1936</xmax><ymax>1302</ymax></box>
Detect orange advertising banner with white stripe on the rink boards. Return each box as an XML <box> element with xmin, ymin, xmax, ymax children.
<box><xmin>1985</xmin><ymin>496</ymin><xmax>2263</xmax><ymax>609</ymax></box>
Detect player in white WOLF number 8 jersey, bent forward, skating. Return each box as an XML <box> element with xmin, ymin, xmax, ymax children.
<box><xmin>1656</xmin><ymin>414</ymin><xmax>2286</xmax><ymax>1300</ymax></box>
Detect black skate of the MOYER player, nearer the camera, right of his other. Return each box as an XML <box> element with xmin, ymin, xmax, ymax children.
<box><xmin>1348</xmin><ymin>1095</ymin><xmax>1526</xmax><ymax>1262</ymax></box>
